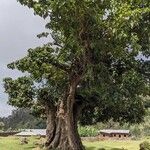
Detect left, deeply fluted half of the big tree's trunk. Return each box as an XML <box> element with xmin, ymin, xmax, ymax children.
<box><xmin>45</xmin><ymin>101</ymin><xmax>71</xmax><ymax>150</ymax></box>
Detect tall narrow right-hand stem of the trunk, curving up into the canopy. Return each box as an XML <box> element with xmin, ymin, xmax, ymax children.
<box><xmin>66</xmin><ymin>78</ymin><xmax>84</xmax><ymax>150</ymax></box>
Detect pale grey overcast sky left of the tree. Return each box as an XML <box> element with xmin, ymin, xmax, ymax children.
<box><xmin>0</xmin><ymin>0</ymin><xmax>45</xmax><ymax>117</ymax></box>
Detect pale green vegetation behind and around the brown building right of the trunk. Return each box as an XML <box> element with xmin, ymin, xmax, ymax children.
<box><xmin>79</xmin><ymin>110</ymin><xmax>150</xmax><ymax>140</ymax></box>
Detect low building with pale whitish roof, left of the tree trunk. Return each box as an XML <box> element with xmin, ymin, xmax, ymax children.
<box><xmin>15</xmin><ymin>129</ymin><xmax>46</xmax><ymax>137</ymax></box>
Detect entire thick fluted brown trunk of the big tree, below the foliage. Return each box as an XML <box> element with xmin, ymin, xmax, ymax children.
<box><xmin>45</xmin><ymin>86</ymin><xmax>84</xmax><ymax>150</ymax></box>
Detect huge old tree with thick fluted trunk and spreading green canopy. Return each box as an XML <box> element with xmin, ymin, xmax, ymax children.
<box><xmin>2</xmin><ymin>0</ymin><xmax>150</xmax><ymax>150</ymax></box>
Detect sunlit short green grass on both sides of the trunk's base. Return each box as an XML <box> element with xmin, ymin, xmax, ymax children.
<box><xmin>0</xmin><ymin>137</ymin><xmax>150</xmax><ymax>150</ymax></box>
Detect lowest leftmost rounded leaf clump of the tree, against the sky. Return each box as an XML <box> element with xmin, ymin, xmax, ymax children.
<box><xmin>4</xmin><ymin>77</ymin><xmax>35</xmax><ymax>108</ymax></box>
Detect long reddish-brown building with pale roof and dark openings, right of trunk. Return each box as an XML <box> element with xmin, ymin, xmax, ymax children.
<box><xmin>99</xmin><ymin>129</ymin><xmax>130</xmax><ymax>139</ymax></box>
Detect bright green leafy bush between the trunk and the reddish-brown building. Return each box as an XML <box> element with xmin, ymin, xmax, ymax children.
<box><xmin>78</xmin><ymin>126</ymin><xmax>98</xmax><ymax>137</ymax></box>
